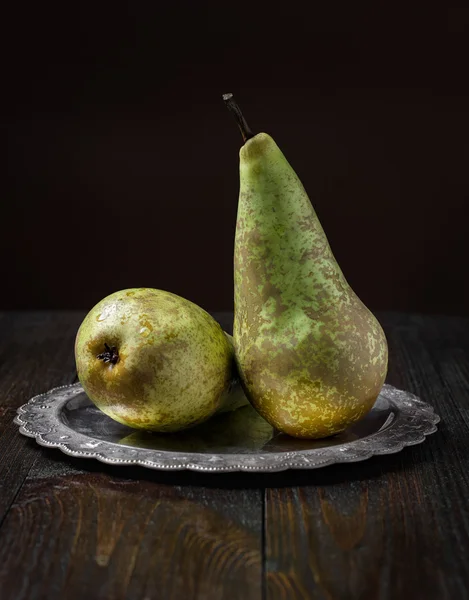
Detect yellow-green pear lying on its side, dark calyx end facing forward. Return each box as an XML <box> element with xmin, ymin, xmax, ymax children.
<box><xmin>75</xmin><ymin>288</ymin><xmax>247</xmax><ymax>432</ymax></box>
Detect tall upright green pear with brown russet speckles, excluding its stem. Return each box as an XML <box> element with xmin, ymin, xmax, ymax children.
<box><xmin>234</xmin><ymin>133</ymin><xmax>388</xmax><ymax>438</ymax></box>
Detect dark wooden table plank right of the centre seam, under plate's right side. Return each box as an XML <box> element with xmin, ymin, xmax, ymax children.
<box><xmin>265</xmin><ymin>315</ymin><xmax>469</xmax><ymax>600</ymax></box>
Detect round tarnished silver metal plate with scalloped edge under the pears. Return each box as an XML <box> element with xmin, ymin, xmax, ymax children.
<box><xmin>15</xmin><ymin>383</ymin><xmax>440</xmax><ymax>472</ymax></box>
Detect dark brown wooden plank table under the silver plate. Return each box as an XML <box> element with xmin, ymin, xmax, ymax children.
<box><xmin>0</xmin><ymin>312</ymin><xmax>469</xmax><ymax>600</ymax></box>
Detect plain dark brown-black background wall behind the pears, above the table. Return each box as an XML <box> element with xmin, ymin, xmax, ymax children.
<box><xmin>0</xmin><ymin>2</ymin><xmax>469</xmax><ymax>314</ymax></box>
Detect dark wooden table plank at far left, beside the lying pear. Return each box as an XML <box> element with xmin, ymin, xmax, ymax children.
<box><xmin>0</xmin><ymin>313</ymin><xmax>81</xmax><ymax>524</ymax></box>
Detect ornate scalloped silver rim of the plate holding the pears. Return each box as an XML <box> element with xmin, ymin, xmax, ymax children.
<box><xmin>14</xmin><ymin>383</ymin><xmax>440</xmax><ymax>472</ymax></box>
